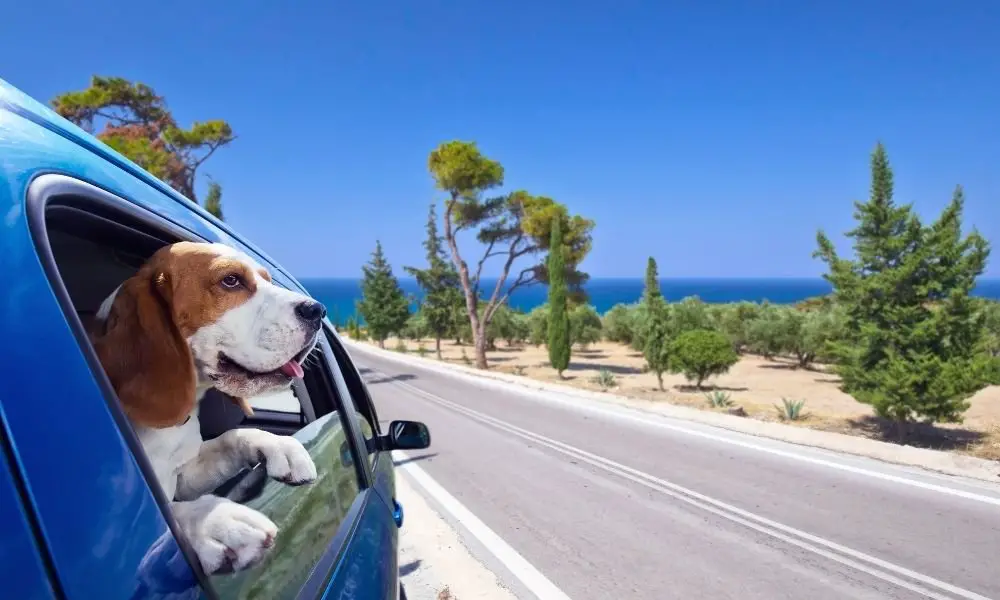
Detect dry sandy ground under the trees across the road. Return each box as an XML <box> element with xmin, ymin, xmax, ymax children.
<box><xmin>366</xmin><ymin>339</ymin><xmax>1000</xmax><ymax>460</ymax></box>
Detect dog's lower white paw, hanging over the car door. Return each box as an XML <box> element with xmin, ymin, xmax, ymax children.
<box><xmin>171</xmin><ymin>496</ymin><xmax>278</xmax><ymax>575</ymax></box>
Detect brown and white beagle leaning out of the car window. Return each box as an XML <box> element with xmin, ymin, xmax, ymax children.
<box><xmin>92</xmin><ymin>242</ymin><xmax>326</xmax><ymax>574</ymax></box>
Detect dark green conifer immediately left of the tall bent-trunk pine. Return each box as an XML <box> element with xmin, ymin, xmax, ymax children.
<box><xmin>403</xmin><ymin>204</ymin><xmax>464</xmax><ymax>360</ymax></box>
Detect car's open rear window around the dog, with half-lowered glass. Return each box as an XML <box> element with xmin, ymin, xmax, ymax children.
<box><xmin>31</xmin><ymin>188</ymin><xmax>367</xmax><ymax>600</ymax></box>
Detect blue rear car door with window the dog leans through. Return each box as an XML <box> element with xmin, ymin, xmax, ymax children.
<box><xmin>4</xmin><ymin>161</ymin><xmax>398</xmax><ymax>600</ymax></box>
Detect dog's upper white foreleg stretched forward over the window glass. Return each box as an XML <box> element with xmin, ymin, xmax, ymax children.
<box><xmin>175</xmin><ymin>429</ymin><xmax>316</xmax><ymax>500</ymax></box>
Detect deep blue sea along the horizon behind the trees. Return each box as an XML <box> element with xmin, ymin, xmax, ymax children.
<box><xmin>300</xmin><ymin>278</ymin><xmax>1000</xmax><ymax>325</ymax></box>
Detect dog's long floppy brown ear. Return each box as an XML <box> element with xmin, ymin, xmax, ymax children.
<box><xmin>92</xmin><ymin>261</ymin><xmax>196</xmax><ymax>427</ymax></box>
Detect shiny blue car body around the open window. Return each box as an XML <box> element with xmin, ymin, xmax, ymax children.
<box><xmin>0</xmin><ymin>80</ymin><xmax>412</xmax><ymax>600</ymax></box>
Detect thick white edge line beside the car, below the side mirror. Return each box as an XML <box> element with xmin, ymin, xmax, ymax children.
<box><xmin>393</xmin><ymin>450</ymin><xmax>570</xmax><ymax>600</ymax></box>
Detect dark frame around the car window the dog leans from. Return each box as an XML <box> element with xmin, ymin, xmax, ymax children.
<box><xmin>25</xmin><ymin>172</ymin><xmax>372</xmax><ymax>600</ymax></box>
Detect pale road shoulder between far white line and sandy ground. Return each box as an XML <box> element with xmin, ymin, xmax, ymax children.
<box><xmin>341</xmin><ymin>337</ymin><xmax>1000</xmax><ymax>484</ymax></box>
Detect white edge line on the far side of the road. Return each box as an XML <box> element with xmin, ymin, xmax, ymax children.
<box><xmin>356</xmin><ymin>350</ymin><xmax>1000</xmax><ymax>506</ymax></box>
